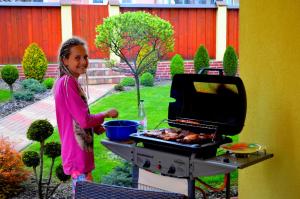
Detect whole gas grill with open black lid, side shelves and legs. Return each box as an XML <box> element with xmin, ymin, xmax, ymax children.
<box><xmin>102</xmin><ymin>74</ymin><xmax>273</xmax><ymax>198</ymax></box>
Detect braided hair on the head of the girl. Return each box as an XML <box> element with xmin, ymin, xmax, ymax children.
<box><xmin>58</xmin><ymin>37</ymin><xmax>86</xmax><ymax>77</ymax></box>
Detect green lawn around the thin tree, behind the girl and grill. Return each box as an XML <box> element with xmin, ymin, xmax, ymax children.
<box><xmin>26</xmin><ymin>85</ymin><xmax>237</xmax><ymax>184</ymax></box>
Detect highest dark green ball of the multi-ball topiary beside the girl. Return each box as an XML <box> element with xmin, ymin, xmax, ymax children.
<box><xmin>27</xmin><ymin>120</ymin><xmax>54</xmax><ymax>142</ymax></box>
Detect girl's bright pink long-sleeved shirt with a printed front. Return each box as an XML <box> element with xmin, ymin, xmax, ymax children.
<box><xmin>54</xmin><ymin>75</ymin><xmax>104</xmax><ymax>175</ymax></box>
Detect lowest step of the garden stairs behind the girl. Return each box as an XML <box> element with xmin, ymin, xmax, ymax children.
<box><xmin>79</xmin><ymin>75</ymin><xmax>126</xmax><ymax>85</ymax></box>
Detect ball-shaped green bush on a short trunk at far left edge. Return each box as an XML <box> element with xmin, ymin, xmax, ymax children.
<box><xmin>1</xmin><ymin>65</ymin><xmax>19</xmax><ymax>96</ymax></box>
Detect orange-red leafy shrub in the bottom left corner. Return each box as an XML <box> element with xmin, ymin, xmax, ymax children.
<box><xmin>0</xmin><ymin>137</ymin><xmax>29</xmax><ymax>198</ymax></box>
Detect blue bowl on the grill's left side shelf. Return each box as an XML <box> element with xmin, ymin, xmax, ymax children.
<box><xmin>103</xmin><ymin>120</ymin><xmax>139</xmax><ymax>141</ymax></box>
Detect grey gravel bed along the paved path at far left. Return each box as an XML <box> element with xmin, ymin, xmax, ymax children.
<box><xmin>0</xmin><ymin>79</ymin><xmax>52</xmax><ymax>119</ymax></box>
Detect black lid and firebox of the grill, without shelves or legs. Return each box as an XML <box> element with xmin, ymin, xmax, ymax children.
<box><xmin>131</xmin><ymin>74</ymin><xmax>246</xmax><ymax>158</ymax></box>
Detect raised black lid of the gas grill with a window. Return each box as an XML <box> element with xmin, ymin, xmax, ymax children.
<box><xmin>168</xmin><ymin>74</ymin><xmax>247</xmax><ymax>135</ymax></box>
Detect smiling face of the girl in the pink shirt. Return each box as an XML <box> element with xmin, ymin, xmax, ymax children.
<box><xmin>63</xmin><ymin>45</ymin><xmax>89</xmax><ymax>78</ymax></box>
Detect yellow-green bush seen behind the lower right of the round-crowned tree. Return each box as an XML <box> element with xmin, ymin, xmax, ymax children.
<box><xmin>136</xmin><ymin>45</ymin><xmax>158</xmax><ymax>77</ymax></box>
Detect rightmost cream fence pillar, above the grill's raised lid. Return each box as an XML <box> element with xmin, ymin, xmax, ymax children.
<box><xmin>216</xmin><ymin>0</ymin><xmax>227</xmax><ymax>61</ymax></box>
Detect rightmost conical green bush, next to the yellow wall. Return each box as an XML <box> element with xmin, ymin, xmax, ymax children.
<box><xmin>223</xmin><ymin>46</ymin><xmax>238</xmax><ymax>76</ymax></box>
